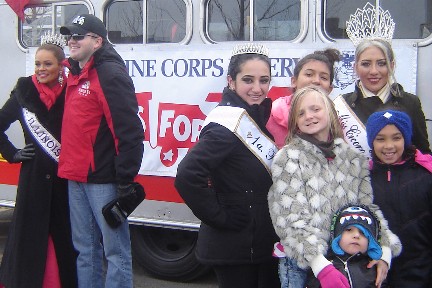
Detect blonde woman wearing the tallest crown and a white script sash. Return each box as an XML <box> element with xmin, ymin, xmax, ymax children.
<box><xmin>335</xmin><ymin>3</ymin><xmax>431</xmax><ymax>157</ymax></box>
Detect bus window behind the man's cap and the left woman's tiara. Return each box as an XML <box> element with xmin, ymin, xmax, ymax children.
<box><xmin>20</xmin><ymin>2</ymin><xmax>89</xmax><ymax>47</ymax></box>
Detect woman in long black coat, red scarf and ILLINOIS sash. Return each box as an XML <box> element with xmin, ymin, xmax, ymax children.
<box><xmin>0</xmin><ymin>34</ymin><xmax>77</xmax><ymax>288</ymax></box>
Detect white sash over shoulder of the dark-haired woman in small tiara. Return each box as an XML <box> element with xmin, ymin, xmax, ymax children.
<box><xmin>203</xmin><ymin>106</ymin><xmax>278</xmax><ymax>174</ymax></box>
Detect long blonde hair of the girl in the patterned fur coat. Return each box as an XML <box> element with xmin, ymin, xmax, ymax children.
<box><xmin>285</xmin><ymin>86</ymin><xmax>343</xmax><ymax>144</ymax></box>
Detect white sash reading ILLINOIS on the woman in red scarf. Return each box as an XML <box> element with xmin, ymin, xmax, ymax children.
<box><xmin>22</xmin><ymin>108</ymin><xmax>61</xmax><ymax>163</ymax></box>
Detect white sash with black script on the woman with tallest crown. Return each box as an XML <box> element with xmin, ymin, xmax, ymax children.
<box><xmin>333</xmin><ymin>95</ymin><xmax>371</xmax><ymax>159</ymax></box>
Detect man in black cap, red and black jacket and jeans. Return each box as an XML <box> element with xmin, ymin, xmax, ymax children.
<box><xmin>58</xmin><ymin>14</ymin><xmax>144</xmax><ymax>288</ymax></box>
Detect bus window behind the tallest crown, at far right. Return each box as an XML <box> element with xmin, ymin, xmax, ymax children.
<box><xmin>323</xmin><ymin>0</ymin><xmax>432</xmax><ymax>39</ymax></box>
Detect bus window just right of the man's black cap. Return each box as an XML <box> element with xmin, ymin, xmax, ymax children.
<box><xmin>107</xmin><ymin>0</ymin><xmax>186</xmax><ymax>43</ymax></box>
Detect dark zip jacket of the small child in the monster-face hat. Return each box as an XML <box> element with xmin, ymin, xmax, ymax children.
<box><xmin>307</xmin><ymin>253</ymin><xmax>388</xmax><ymax>288</ymax></box>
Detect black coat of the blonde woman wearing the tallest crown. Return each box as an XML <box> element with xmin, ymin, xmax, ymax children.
<box><xmin>343</xmin><ymin>84</ymin><xmax>431</xmax><ymax>153</ymax></box>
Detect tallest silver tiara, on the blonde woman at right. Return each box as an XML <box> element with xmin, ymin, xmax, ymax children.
<box><xmin>346</xmin><ymin>1</ymin><xmax>395</xmax><ymax>46</ymax></box>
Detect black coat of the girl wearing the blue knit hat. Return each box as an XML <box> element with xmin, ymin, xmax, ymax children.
<box><xmin>371</xmin><ymin>159</ymin><xmax>432</xmax><ymax>288</ymax></box>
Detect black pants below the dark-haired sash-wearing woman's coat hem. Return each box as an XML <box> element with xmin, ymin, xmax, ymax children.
<box><xmin>213</xmin><ymin>258</ymin><xmax>280</xmax><ymax>288</ymax></box>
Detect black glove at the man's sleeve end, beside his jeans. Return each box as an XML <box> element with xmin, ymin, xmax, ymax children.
<box><xmin>102</xmin><ymin>182</ymin><xmax>145</xmax><ymax>228</ymax></box>
